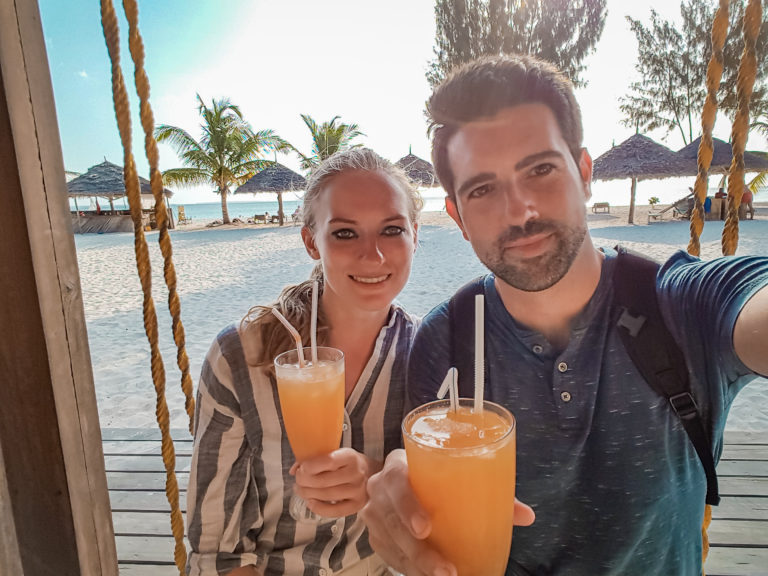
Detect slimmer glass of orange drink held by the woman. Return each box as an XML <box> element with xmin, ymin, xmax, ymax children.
<box><xmin>275</xmin><ymin>347</ymin><xmax>344</xmax><ymax>462</ymax></box>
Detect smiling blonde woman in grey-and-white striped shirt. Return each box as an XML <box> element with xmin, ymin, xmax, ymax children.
<box><xmin>187</xmin><ymin>148</ymin><xmax>421</xmax><ymax>576</ymax></box>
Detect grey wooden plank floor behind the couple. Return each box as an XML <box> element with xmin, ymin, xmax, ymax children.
<box><xmin>102</xmin><ymin>428</ymin><xmax>768</xmax><ymax>576</ymax></box>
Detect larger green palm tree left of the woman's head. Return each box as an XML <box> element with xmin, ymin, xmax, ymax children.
<box><xmin>155</xmin><ymin>94</ymin><xmax>288</xmax><ymax>224</ymax></box>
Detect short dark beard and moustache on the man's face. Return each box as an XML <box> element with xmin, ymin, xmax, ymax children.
<box><xmin>478</xmin><ymin>220</ymin><xmax>587</xmax><ymax>292</ymax></box>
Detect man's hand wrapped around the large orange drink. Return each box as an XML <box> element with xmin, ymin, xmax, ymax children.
<box><xmin>360</xmin><ymin>450</ymin><xmax>535</xmax><ymax>576</ymax></box>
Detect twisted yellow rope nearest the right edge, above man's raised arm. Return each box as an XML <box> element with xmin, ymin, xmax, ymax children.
<box><xmin>722</xmin><ymin>0</ymin><xmax>763</xmax><ymax>256</ymax></box>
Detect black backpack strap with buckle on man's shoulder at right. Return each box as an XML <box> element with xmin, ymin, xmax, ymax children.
<box><xmin>613</xmin><ymin>246</ymin><xmax>720</xmax><ymax>505</ymax></box>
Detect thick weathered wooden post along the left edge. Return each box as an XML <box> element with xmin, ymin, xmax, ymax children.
<box><xmin>0</xmin><ymin>0</ymin><xmax>117</xmax><ymax>576</ymax></box>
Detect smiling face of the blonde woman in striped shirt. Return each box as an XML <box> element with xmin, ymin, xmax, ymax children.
<box><xmin>301</xmin><ymin>170</ymin><xmax>416</xmax><ymax>318</ymax></box>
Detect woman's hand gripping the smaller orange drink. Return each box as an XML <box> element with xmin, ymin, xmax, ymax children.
<box><xmin>291</xmin><ymin>448</ymin><xmax>382</xmax><ymax>518</ymax></box>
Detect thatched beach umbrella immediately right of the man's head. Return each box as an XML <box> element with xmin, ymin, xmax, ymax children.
<box><xmin>592</xmin><ymin>134</ymin><xmax>696</xmax><ymax>224</ymax></box>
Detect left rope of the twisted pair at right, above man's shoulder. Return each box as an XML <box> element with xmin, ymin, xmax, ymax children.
<box><xmin>688</xmin><ymin>0</ymin><xmax>729</xmax><ymax>256</ymax></box>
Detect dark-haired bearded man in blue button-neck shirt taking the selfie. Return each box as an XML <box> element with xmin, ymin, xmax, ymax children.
<box><xmin>363</xmin><ymin>56</ymin><xmax>768</xmax><ymax>576</ymax></box>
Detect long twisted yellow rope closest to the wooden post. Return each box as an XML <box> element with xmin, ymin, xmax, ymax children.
<box><xmin>101</xmin><ymin>0</ymin><xmax>187</xmax><ymax>576</ymax></box>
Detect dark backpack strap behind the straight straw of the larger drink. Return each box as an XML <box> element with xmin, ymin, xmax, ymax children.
<box><xmin>448</xmin><ymin>276</ymin><xmax>490</xmax><ymax>398</ymax></box>
